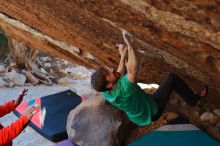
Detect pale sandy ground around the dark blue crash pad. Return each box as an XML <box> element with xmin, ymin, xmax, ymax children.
<box><xmin>0</xmin><ymin>67</ymin><xmax>94</xmax><ymax>146</ymax></box>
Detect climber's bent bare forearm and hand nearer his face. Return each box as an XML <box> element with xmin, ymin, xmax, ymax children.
<box><xmin>117</xmin><ymin>44</ymin><xmax>127</xmax><ymax>76</ymax></box>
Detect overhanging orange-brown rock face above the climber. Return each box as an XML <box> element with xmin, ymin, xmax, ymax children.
<box><xmin>0</xmin><ymin>0</ymin><xmax>220</xmax><ymax>105</ymax></box>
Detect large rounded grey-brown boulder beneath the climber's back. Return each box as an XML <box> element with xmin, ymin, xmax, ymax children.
<box><xmin>67</xmin><ymin>93</ymin><xmax>135</xmax><ymax>146</ymax></box>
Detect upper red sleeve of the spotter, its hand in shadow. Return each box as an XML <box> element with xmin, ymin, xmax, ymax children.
<box><xmin>0</xmin><ymin>100</ymin><xmax>16</xmax><ymax>117</ymax></box>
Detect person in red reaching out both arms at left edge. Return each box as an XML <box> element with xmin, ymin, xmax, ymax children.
<box><xmin>0</xmin><ymin>89</ymin><xmax>39</xmax><ymax>146</ymax></box>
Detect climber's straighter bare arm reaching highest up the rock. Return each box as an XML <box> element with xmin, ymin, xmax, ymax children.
<box><xmin>123</xmin><ymin>32</ymin><xmax>138</xmax><ymax>83</ymax></box>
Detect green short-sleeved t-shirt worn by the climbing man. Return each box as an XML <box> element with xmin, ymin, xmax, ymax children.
<box><xmin>103</xmin><ymin>74</ymin><xmax>158</xmax><ymax>126</ymax></box>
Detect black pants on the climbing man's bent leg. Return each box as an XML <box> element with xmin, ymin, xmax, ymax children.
<box><xmin>152</xmin><ymin>73</ymin><xmax>199</xmax><ymax>121</ymax></box>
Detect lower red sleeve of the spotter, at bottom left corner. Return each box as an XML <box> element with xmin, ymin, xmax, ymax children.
<box><xmin>0</xmin><ymin>116</ymin><xmax>29</xmax><ymax>145</ymax></box>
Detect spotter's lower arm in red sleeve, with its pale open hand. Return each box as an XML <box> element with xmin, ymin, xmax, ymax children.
<box><xmin>0</xmin><ymin>106</ymin><xmax>38</xmax><ymax>145</ymax></box>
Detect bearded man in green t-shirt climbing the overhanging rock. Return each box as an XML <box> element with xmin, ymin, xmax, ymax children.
<box><xmin>91</xmin><ymin>33</ymin><xmax>207</xmax><ymax>126</ymax></box>
